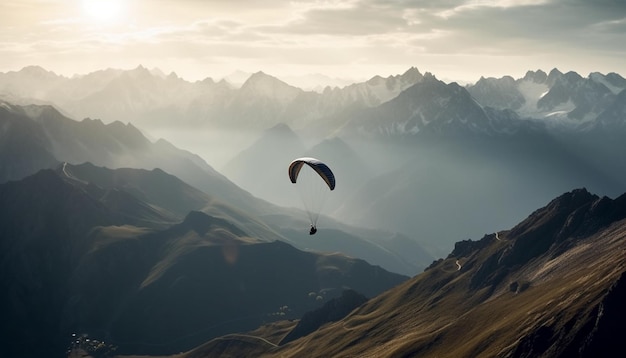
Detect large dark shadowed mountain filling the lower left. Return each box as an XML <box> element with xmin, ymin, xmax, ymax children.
<box><xmin>0</xmin><ymin>169</ymin><xmax>407</xmax><ymax>357</ymax></box>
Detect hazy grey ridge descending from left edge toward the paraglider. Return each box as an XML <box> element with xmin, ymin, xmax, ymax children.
<box><xmin>0</xmin><ymin>98</ymin><xmax>268</xmax><ymax>212</ymax></box>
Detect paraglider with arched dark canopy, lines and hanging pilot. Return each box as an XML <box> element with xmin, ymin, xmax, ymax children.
<box><xmin>289</xmin><ymin>157</ymin><xmax>335</xmax><ymax>235</ymax></box>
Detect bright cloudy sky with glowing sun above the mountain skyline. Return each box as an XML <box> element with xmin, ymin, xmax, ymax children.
<box><xmin>0</xmin><ymin>0</ymin><xmax>626</xmax><ymax>83</ymax></box>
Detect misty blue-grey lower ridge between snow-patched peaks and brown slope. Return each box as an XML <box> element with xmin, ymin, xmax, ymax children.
<box><xmin>334</xmin><ymin>133</ymin><xmax>621</xmax><ymax>255</ymax></box>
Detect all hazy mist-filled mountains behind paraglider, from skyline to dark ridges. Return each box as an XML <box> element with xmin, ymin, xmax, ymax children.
<box><xmin>0</xmin><ymin>66</ymin><xmax>626</xmax><ymax>256</ymax></box>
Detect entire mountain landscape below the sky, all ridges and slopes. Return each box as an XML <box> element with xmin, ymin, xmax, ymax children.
<box><xmin>0</xmin><ymin>66</ymin><xmax>626</xmax><ymax>357</ymax></box>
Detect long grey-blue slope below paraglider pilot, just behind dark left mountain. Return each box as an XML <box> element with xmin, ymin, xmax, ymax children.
<box><xmin>63</xmin><ymin>163</ymin><xmax>432</xmax><ymax>275</ymax></box>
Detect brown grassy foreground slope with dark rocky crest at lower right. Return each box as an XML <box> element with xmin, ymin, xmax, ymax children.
<box><xmin>186</xmin><ymin>189</ymin><xmax>626</xmax><ymax>357</ymax></box>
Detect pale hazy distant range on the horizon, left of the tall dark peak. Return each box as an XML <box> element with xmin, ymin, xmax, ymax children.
<box><xmin>0</xmin><ymin>66</ymin><xmax>422</xmax><ymax>133</ymax></box>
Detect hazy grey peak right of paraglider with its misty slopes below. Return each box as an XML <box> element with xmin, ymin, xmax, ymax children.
<box><xmin>326</xmin><ymin>75</ymin><xmax>626</xmax><ymax>255</ymax></box>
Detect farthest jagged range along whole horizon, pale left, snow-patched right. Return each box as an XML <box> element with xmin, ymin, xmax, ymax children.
<box><xmin>0</xmin><ymin>66</ymin><xmax>626</xmax><ymax>134</ymax></box>
